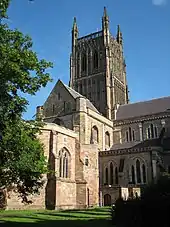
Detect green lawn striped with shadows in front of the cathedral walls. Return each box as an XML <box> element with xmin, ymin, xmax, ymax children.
<box><xmin>0</xmin><ymin>208</ymin><xmax>112</xmax><ymax>227</ymax></box>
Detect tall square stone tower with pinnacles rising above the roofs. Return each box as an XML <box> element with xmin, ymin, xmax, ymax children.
<box><xmin>69</xmin><ymin>7</ymin><xmax>128</xmax><ymax>119</ymax></box>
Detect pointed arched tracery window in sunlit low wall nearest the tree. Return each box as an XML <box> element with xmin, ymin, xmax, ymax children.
<box><xmin>59</xmin><ymin>148</ymin><xmax>69</xmax><ymax>178</ymax></box>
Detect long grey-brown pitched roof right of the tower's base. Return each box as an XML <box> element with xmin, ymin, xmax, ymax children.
<box><xmin>116</xmin><ymin>96</ymin><xmax>170</xmax><ymax>120</ymax></box>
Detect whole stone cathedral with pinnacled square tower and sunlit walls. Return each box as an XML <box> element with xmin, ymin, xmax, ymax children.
<box><xmin>4</xmin><ymin>8</ymin><xmax>170</xmax><ymax>209</ymax></box>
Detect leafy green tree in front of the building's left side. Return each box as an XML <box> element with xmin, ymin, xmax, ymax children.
<box><xmin>0</xmin><ymin>0</ymin><xmax>52</xmax><ymax>202</ymax></box>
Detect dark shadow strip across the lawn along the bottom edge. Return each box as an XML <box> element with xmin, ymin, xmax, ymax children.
<box><xmin>0</xmin><ymin>217</ymin><xmax>113</xmax><ymax>227</ymax></box>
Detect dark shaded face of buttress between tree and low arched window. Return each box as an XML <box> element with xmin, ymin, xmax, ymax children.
<box><xmin>45</xmin><ymin>132</ymin><xmax>56</xmax><ymax>210</ymax></box>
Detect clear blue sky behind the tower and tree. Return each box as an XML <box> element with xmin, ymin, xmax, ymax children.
<box><xmin>6</xmin><ymin>0</ymin><xmax>170</xmax><ymax>119</ymax></box>
